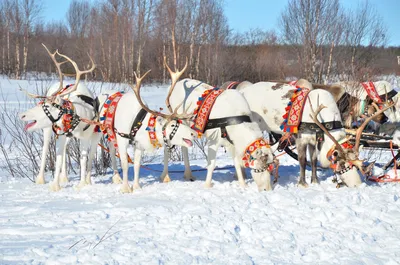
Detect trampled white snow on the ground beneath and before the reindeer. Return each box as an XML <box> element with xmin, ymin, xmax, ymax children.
<box><xmin>0</xmin><ymin>75</ymin><xmax>400</xmax><ymax>264</ymax></box>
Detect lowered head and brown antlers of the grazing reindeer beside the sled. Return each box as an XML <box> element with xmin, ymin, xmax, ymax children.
<box><xmin>310</xmin><ymin>102</ymin><xmax>393</xmax><ymax>187</ymax></box>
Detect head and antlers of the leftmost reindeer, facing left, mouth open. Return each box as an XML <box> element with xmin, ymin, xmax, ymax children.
<box><xmin>19</xmin><ymin>44</ymin><xmax>96</xmax><ymax>131</ymax></box>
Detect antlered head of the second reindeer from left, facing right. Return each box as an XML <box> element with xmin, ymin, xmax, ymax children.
<box><xmin>131</xmin><ymin>58</ymin><xmax>195</xmax><ymax>147</ymax></box>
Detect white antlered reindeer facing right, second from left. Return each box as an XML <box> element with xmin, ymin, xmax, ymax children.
<box><xmin>93</xmin><ymin>68</ymin><xmax>194</xmax><ymax>193</ymax></box>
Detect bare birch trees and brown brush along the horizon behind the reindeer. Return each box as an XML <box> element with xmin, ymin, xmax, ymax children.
<box><xmin>0</xmin><ymin>0</ymin><xmax>400</xmax><ymax>84</ymax></box>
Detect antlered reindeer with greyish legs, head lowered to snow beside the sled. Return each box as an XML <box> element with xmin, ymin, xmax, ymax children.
<box><xmin>241</xmin><ymin>82</ymin><xmax>393</xmax><ymax>187</ymax></box>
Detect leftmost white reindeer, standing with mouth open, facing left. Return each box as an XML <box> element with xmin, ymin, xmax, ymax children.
<box><xmin>20</xmin><ymin>44</ymin><xmax>97</xmax><ymax>191</ymax></box>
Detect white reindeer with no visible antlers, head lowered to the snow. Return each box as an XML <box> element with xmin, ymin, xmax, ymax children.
<box><xmin>162</xmin><ymin>72</ymin><xmax>273</xmax><ymax>191</ymax></box>
